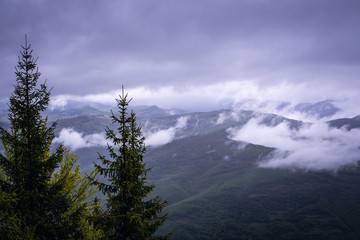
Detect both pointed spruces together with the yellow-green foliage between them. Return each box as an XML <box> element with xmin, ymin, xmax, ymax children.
<box><xmin>0</xmin><ymin>36</ymin><xmax>171</xmax><ymax>240</ymax></box>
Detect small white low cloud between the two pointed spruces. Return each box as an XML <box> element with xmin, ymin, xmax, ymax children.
<box><xmin>53</xmin><ymin>128</ymin><xmax>107</xmax><ymax>151</ymax></box>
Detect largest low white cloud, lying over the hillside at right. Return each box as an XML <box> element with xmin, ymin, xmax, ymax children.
<box><xmin>229</xmin><ymin>118</ymin><xmax>360</xmax><ymax>171</ymax></box>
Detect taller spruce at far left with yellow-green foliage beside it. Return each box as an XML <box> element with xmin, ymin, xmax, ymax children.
<box><xmin>0</xmin><ymin>37</ymin><xmax>100</xmax><ymax>239</ymax></box>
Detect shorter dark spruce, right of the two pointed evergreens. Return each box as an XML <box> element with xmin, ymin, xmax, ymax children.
<box><xmin>95</xmin><ymin>89</ymin><xmax>170</xmax><ymax>240</ymax></box>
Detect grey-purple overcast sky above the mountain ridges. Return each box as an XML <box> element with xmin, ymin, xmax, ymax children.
<box><xmin>0</xmin><ymin>0</ymin><xmax>360</xmax><ymax>112</ymax></box>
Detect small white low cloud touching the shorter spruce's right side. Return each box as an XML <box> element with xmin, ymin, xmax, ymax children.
<box><xmin>145</xmin><ymin>116</ymin><xmax>189</xmax><ymax>147</ymax></box>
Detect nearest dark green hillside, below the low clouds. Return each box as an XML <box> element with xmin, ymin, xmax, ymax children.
<box><xmin>143</xmin><ymin>128</ymin><xmax>360</xmax><ymax>239</ymax></box>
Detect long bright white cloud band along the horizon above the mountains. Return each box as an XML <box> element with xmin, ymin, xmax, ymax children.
<box><xmin>52</xmin><ymin>79</ymin><xmax>360</xmax><ymax>120</ymax></box>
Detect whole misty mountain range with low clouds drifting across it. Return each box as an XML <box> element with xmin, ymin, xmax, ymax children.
<box><xmin>0</xmin><ymin>101</ymin><xmax>360</xmax><ymax>239</ymax></box>
